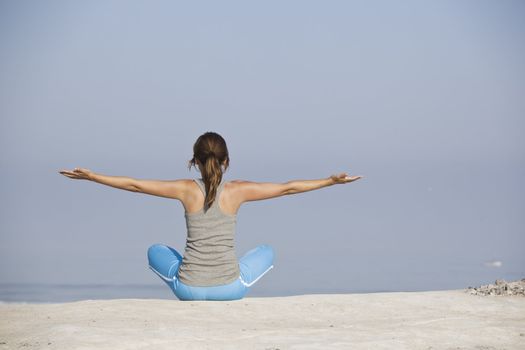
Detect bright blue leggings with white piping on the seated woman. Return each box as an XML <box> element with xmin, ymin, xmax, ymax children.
<box><xmin>148</xmin><ymin>244</ymin><xmax>274</xmax><ymax>300</ymax></box>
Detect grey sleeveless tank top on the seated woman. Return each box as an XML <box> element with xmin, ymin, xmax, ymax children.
<box><xmin>178</xmin><ymin>178</ymin><xmax>240</xmax><ymax>287</ymax></box>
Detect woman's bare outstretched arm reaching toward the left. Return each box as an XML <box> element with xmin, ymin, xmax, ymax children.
<box><xmin>59</xmin><ymin>168</ymin><xmax>187</xmax><ymax>199</ymax></box>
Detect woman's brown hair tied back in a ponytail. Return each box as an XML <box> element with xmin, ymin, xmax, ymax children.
<box><xmin>188</xmin><ymin>131</ymin><xmax>230</xmax><ymax>211</ymax></box>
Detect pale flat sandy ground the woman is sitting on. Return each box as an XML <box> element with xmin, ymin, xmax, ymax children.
<box><xmin>0</xmin><ymin>290</ymin><xmax>525</xmax><ymax>350</ymax></box>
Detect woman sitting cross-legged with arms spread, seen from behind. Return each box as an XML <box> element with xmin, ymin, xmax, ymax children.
<box><xmin>60</xmin><ymin>132</ymin><xmax>362</xmax><ymax>300</ymax></box>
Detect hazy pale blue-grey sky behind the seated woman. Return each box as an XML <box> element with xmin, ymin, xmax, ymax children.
<box><xmin>0</xmin><ymin>1</ymin><xmax>525</xmax><ymax>295</ymax></box>
